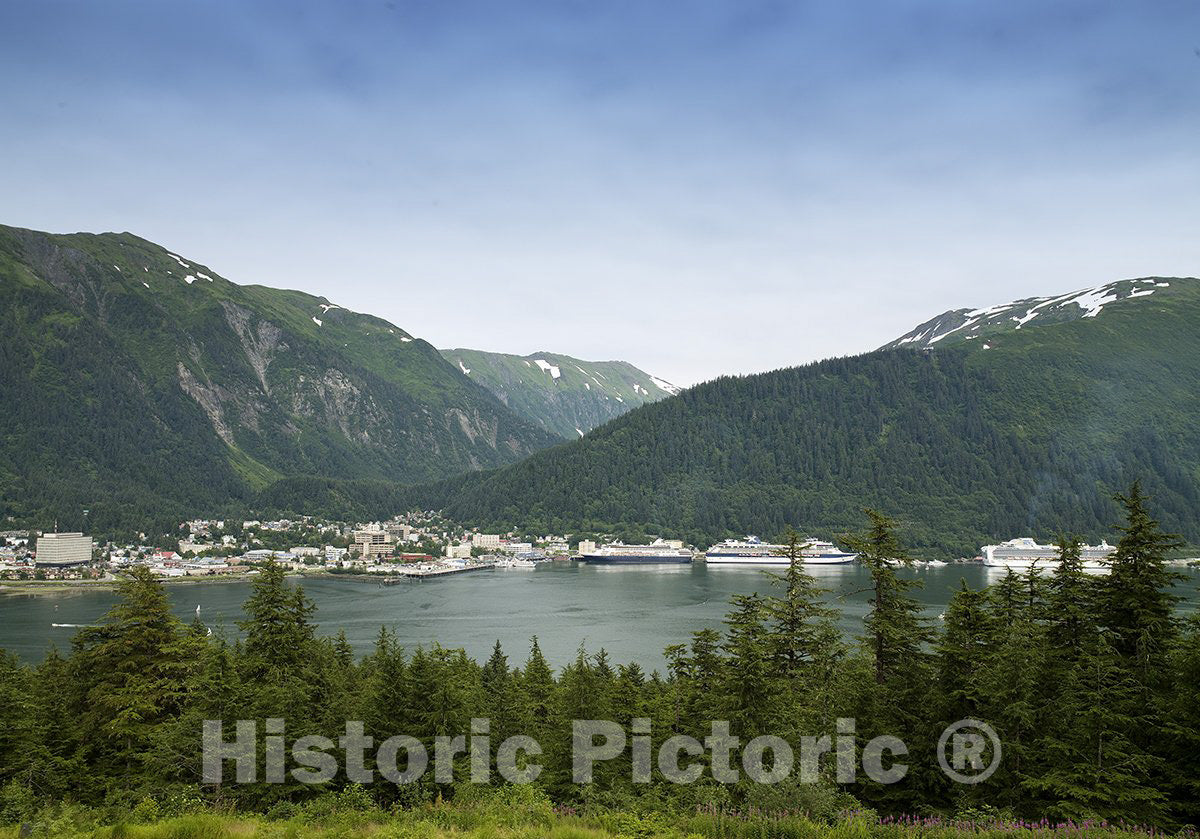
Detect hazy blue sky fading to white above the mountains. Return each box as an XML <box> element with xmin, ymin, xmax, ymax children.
<box><xmin>0</xmin><ymin>0</ymin><xmax>1200</xmax><ymax>385</ymax></box>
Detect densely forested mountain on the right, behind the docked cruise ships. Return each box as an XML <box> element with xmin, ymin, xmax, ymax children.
<box><xmin>422</xmin><ymin>278</ymin><xmax>1200</xmax><ymax>557</ymax></box>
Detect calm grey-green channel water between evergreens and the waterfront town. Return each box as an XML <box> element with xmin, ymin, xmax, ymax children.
<box><xmin>0</xmin><ymin>562</ymin><xmax>1200</xmax><ymax>670</ymax></box>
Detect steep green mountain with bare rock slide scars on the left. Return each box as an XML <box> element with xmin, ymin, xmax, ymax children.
<box><xmin>0</xmin><ymin>227</ymin><xmax>559</xmax><ymax>535</ymax></box>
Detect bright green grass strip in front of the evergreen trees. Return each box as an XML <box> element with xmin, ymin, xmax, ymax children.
<box><xmin>0</xmin><ymin>786</ymin><xmax>1195</xmax><ymax>839</ymax></box>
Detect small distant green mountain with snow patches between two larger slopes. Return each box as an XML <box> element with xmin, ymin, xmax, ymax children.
<box><xmin>442</xmin><ymin>349</ymin><xmax>679</xmax><ymax>439</ymax></box>
